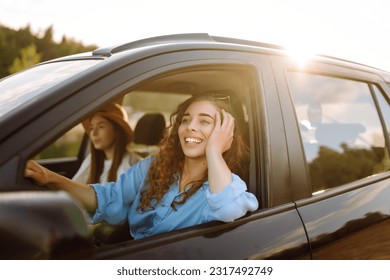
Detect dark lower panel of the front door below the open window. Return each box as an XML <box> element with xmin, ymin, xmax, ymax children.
<box><xmin>97</xmin><ymin>204</ymin><xmax>310</xmax><ymax>259</ymax></box>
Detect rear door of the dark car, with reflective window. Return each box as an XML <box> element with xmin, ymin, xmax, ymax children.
<box><xmin>273</xmin><ymin>55</ymin><xmax>390</xmax><ymax>259</ymax></box>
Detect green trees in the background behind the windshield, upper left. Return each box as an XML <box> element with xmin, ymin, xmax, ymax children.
<box><xmin>0</xmin><ymin>25</ymin><xmax>97</xmax><ymax>78</ymax></box>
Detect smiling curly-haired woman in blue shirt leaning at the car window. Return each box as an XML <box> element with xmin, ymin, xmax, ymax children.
<box><xmin>25</xmin><ymin>94</ymin><xmax>258</xmax><ymax>239</ymax></box>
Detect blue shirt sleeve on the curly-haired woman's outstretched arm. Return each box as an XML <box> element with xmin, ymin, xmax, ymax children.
<box><xmin>91</xmin><ymin>157</ymin><xmax>152</xmax><ymax>224</ymax></box>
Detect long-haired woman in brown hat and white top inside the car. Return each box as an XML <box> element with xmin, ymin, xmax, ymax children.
<box><xmin>72</xmin><ymin>103</ymin><xmax>142</xmax><ymax>184</ymax></box>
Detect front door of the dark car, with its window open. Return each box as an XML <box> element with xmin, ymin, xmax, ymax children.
<box><xmin>84</xmin><ymin>48</ymin><xmax>310</xmax><ymax>259</ymax></box>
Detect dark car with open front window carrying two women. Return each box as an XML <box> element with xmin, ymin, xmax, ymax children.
<box><xmin>0</xmin><ymin>33</ymin><xmax>390</xmax><ymax>260</ymax></box>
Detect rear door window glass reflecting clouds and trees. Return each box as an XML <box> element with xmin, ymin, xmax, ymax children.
<box><xmin>288</xmin><ymin>72</ymin><xmax>388</xmax><ymax>192</ymax></box>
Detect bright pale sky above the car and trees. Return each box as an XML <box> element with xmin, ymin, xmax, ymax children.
<box><xmin>0</xmin><ymin>0</ymin><xmax>390</xmax><ymax>71</ymax></box>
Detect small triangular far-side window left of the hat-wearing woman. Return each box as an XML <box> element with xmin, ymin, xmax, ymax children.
<box><xmin>34</xmin><ymin>124</ymin><xmax>84</xmax><ymax>160</ymax></box>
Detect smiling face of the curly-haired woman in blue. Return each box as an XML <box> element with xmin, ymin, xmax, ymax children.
<box><xmin>178</xmin><ymin>101</ymin><xmax>219</xmax><ymax>158</ymax></box>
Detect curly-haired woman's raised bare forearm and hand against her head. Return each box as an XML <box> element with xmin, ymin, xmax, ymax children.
<box><xmin>206</xmin><ymin>110</ymin><xmax>234</xmax><ymax>193</ymax></box>
